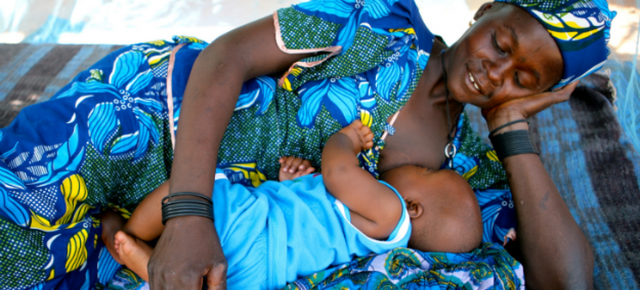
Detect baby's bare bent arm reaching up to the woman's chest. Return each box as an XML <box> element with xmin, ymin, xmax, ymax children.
<box><xmin>322</xmin><ymin>120</ymin><xmax>403</xmax><ymax>239</ymax></box>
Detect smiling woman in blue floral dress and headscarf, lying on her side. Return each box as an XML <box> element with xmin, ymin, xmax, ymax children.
<box><xmin>0</xmin><ymin>1</ymin><xmax>609</xmax><ymax>289</ymax></box>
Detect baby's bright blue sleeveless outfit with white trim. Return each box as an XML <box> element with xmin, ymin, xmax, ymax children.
<box><xmin>213</xmin><ymin>170</ymin><xmax>411</xmax><ymax>289</ymax></box>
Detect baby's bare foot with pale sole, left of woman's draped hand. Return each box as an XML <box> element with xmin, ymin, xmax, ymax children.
<box><xmin>115</xmin><ymin>231</ymin><xmax>153</xmax><ymax>282</ymax></box>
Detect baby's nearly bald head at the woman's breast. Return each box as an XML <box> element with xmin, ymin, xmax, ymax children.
<box><xmin>381</xmin><ymin>165</ymin><xmax>482</xmax><ymax>253</ymax></box>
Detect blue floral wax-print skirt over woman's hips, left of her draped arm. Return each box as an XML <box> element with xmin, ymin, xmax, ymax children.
<box><xmin>0</xmin><ymin>42</ymin><xmax>184</xmax><ymax>289</ymax></box>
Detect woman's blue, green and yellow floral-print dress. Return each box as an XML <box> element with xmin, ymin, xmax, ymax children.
<box><xmin>0</xmin><ymin>0</ymin><xmax>523</xmax><ymax>289</ymax></box>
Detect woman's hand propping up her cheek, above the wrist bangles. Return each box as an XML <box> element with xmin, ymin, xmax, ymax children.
<box><xmin>482</xmin><ymin>82</ymin><xmax>578</xmax><ymax>132</ymax></box>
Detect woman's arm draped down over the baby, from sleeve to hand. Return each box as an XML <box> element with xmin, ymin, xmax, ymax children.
<box><xmin>149</xmin><ymin>17</ymin><xmax>309</xmax><ymax>289</ymax></box>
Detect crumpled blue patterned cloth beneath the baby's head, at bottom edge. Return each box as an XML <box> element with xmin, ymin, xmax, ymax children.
<box><xmin>284</xmin><ymin>243</ymin><xmax>525</xmax><ymax>290</ymax></box>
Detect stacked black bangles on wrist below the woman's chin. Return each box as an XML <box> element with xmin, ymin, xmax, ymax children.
<box><xmin>489</xmin><ymin>130</ymin><xmax>538</xmax><ymax>161</ymax></box>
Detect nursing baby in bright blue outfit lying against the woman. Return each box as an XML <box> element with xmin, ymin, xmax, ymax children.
<box><xmin>103</xmin><ymin>121</ymin><xmax>482</xmax><ymax>289</ymax></box>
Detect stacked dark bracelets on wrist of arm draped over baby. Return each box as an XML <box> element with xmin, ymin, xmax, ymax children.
<box><xmin>162</xmin><ymin>192</ymin><xmax>213</xmax><ymax>225</ymax></box>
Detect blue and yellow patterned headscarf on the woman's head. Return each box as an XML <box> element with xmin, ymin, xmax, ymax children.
<box><xmin>495</xmin><ymin>0</ymin><xmax>616</xmax><ymax>88</ymax></box>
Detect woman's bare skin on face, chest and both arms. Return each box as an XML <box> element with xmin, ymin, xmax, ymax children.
<box><xmin>149</xmin><ymin>4</ymin><xmax>593</xmax><ymax>289</ymax></box>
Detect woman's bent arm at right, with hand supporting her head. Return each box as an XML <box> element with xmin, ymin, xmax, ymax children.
<box><xmin>483</xmin><ymin>84</ymin><xmax>594</xmax><ymax>289</ymax></box>
